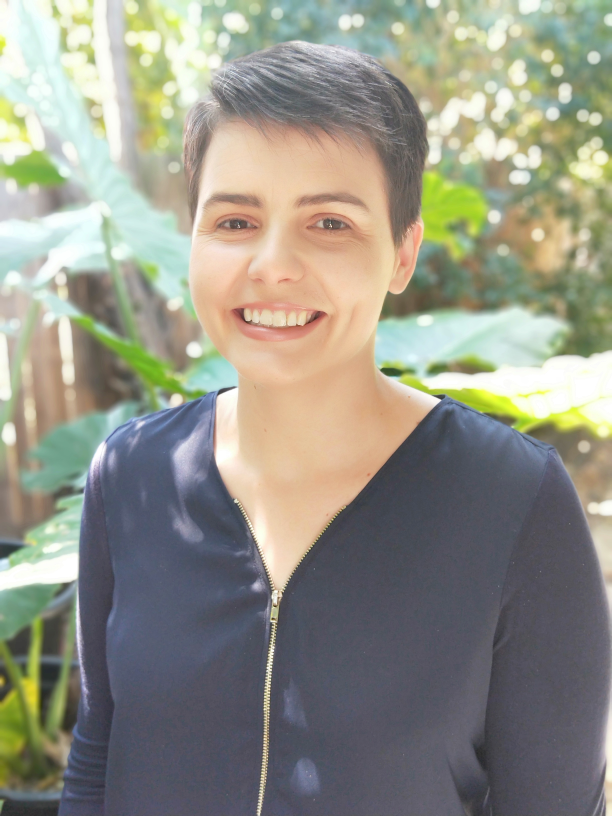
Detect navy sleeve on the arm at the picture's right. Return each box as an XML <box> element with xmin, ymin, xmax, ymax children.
<box><xmin>485</xmin><ymin>448</ymin><xmax>610</xmax><ymax>816</ymax></box>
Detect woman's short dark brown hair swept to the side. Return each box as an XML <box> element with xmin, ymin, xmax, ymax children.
<box><xmin>183</xmin><ymin>40</ymin><xmax>428</xmax><ymax>247</ymax></box>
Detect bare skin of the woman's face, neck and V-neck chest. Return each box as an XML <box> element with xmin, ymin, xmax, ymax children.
<box><xmin>190</xmin><ymin>121</ymin><xmax>439</xmax><ymax>588</ymax></box>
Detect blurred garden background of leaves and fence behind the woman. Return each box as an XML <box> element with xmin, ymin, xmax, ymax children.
<box><xmin>0</xmin><ymin>0</ymin><xmax>612</xmax><ymax>800</ymax></box>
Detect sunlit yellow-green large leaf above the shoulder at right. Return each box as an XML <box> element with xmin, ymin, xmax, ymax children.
<box><xmin>400</xmin><ymin>351</ymin><xmax>612</xmax><ymax>438</ymax></box>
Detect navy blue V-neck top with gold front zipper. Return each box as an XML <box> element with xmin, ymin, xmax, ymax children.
<box><xmin>59</xmin><ymin>389</ymin><xmax>610</xmax><ymax>816</ymax></box>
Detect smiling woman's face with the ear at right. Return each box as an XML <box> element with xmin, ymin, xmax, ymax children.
<box><xmin>189</xmin><ymin>121</ymin><xmax>423</xmax><ymax>384</ymax></box>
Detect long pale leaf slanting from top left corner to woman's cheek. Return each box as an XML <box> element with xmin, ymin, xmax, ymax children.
<box><xmin>0</xmin><ymin>0</ymin><xmax>195</xmax><ymax>315</ymax></box>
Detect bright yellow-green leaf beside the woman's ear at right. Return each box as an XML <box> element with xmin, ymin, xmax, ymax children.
<box><xmin>421</xmin><ymin>171</ymin><xmax>489</xmax><ymax>258</ymax></box>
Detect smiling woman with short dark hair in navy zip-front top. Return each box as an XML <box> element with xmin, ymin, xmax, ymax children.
<box><xmin>60</xmin><ymin>42</ymin><xmax>610</xmax><ymax>816</ymax></box>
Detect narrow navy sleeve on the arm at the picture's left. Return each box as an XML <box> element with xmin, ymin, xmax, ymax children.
<box><xmin>59</xmin><ymin>442</ymin><xmax>113</xmax><ymax>816</ymax></box>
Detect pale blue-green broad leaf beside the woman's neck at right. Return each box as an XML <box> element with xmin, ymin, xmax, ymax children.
<box><xmin>376</xmin><ymin>306</ymin><xmax>569</xmax><ymax>376</ymax></box>
